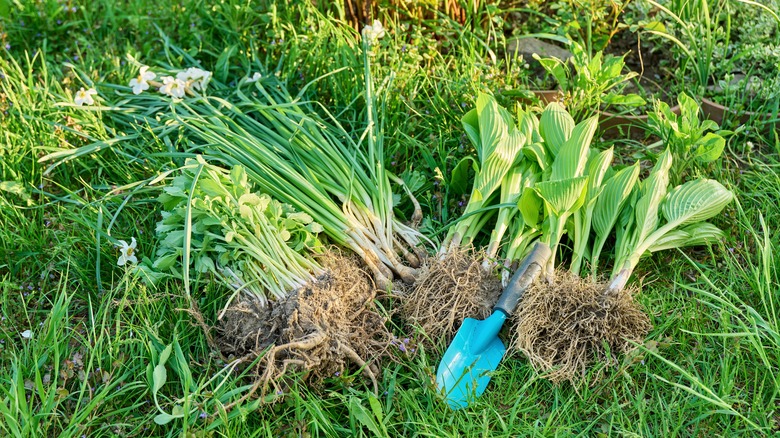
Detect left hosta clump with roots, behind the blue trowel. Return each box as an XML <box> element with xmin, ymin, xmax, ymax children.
<box><xmin>405</xmin><ymin>95</ymin><xmax>596</xmax><ymax>348</ymax></box>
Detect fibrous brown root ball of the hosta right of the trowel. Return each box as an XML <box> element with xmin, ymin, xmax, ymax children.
<box><xmin>513</xmin><ymin>272</ymin><xmax>652</xmax><ymax>383</ymax></box>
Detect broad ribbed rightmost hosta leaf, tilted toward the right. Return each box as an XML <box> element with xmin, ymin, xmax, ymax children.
<box><xmin>661</xmin><ymin>179</ymin><xmax>734</xmax><ymax>226</ymax></box>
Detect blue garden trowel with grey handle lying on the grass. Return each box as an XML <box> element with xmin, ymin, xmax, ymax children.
<box><xmin>436</xmin><ymin>242</ymin><xmax>551</xmax><ymax>409</ymax></box>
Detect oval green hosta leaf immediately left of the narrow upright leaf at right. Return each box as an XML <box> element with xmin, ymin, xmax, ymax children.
<box><xmin>593</xmin><ymin>163</ymin><xmax>639</xmax><ymax>236</ymax></box>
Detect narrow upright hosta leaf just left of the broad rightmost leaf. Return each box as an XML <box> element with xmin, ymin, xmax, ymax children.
<box><xmin>633</xmin><ymin>149</ymin><xmax>672</xmax><ymax>243</ymax></box>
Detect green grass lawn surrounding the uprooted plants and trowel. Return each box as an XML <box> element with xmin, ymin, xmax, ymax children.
<box><xmin>0</xmin><ymin>0</ymin><xmax>780</xmax><ymax>437</ymax></box>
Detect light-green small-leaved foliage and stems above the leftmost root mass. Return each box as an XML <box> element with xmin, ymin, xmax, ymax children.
<box><xmin>153</xmin><ymin>157</ymin><xmax>322</xmax><ymax>303</ymax></box>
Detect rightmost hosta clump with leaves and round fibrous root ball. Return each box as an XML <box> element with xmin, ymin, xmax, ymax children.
<box><xmin>514</xmin><ymin>150</ymin><xmax>734</xmax><ymax>381</ymax></box>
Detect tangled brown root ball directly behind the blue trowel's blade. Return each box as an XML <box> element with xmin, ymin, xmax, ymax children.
<box><xmin>401</xmin><ymin>250</ymin><xmax>501</xmax><ymax>345</ymax></box>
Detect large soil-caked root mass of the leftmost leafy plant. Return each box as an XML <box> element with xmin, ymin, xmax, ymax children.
<box><xmin>219</xmin><ymin>253</ymin><xmax>392</xmax><ymax>395</ymax></box>
